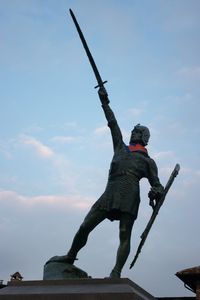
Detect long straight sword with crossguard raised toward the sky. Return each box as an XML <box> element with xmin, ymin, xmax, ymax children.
<box><xmin>69</xmin><ymin>9</ymin><xmax>107</xmax><ymax>88</ymax></box>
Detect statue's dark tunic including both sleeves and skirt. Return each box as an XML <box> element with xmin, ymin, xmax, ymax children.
<box><xmin>92</xmin><ymin>104</ymin><xmax>162</xmax><ymax>221</ymax></box>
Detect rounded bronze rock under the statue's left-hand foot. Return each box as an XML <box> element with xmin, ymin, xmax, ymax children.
<box><xmin>43</xmin><ymin>256</ymin><xmax>91</xmax><ymax>280</ymax></box>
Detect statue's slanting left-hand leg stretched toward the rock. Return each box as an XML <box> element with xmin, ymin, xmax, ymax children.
<box><xmin>66</xmin><ymin>209</ymin><xmax>107</xmax><ymax>264</ymax></box>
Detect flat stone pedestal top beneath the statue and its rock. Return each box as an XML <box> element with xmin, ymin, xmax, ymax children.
<box><xmin>0</xmin><ymin>278</ymin><xmax>155</xmax><ymax>300</ymax></box>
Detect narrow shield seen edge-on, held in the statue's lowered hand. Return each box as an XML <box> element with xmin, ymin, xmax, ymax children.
<box><xmin>129</xmin><ymin>164</ymin><xmax>180</xmax><ymax>269</ymax></box>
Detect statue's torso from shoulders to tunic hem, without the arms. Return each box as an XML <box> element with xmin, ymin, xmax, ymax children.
<box><xmin>94</xmin><ymin>144</ymin><xmax>150</xmax><ymax>220</ymax></box>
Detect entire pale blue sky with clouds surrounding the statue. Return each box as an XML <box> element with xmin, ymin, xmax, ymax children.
<box><xmin>0</xmin><ymin>0</ymin><xmax>200</xmax><ymax>297</ymax></box>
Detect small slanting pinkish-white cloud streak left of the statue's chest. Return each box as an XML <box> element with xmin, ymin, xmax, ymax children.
<box><xmin>20</xmin><ymin>134</ymin><xmax>54</xmax><ymax>158</ymax></box>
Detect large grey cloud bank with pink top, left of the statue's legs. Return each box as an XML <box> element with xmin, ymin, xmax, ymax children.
<box><xmin>0</xmin><ymin>190</ymin><xmax>93</xmax><ymax>280</ymax></box>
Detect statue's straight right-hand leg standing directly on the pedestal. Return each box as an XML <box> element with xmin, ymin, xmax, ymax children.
<box><xmin>110</xmin><ymin>213</ymin><xmax>134</xmax><ymax>278</ymax></box>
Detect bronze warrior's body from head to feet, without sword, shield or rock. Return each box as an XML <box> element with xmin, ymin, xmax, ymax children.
<box><xmin>59</xmin><ymin>86</ymin><xmax>164</xmax><ymax>278</ymax></box>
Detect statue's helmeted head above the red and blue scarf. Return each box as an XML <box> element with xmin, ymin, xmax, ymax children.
<box><xmin>130</xmin><ymin>124</ymin><xmax>150</xmax><ymax>146</ymax></box>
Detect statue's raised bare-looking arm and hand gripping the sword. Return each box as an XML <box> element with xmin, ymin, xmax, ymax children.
<box><xmin>98</xmin><ymin>87</ymin><xmax>123</xmax><ymax>150</ymax></box>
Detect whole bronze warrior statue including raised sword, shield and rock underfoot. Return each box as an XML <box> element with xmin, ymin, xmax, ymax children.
<box><xmin>44</xmin><ymin>9</ymin><xmax>180</xmax><ymax>279</ymax></box>
